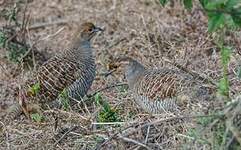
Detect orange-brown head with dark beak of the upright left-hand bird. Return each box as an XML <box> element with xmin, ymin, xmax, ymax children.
<box><xmin>76</xmin><ymin>22</ymin><xmax>103</xmax><ymax>41</ymax></box>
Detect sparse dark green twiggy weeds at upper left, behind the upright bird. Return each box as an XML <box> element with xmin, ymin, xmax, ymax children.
<box><xmin>0</xmin><ymin>1</ymin><xmax>30</xmax><ymax>63</ymax></box>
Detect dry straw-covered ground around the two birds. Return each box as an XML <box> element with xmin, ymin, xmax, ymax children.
<box><xmin>0</xmin><ymin>0</ymin><xmax>241</xmax><ymax>149</ymax></box>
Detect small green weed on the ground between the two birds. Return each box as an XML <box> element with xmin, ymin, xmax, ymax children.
<box><xmin>95</xmin><ymin>93</ymin><xmax>121</xmax><ymax>122</ymax></box>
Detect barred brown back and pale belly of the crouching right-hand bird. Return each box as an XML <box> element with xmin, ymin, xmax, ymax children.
<box><xmin>132</xmin><ymin>68</ymin><xmax>193</xmax><ymax>113</ymax></box>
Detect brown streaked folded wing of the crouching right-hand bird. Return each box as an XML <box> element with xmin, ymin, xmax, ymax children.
<box><xmin>135</xmin><ymin>69</ymin><xmax>191</xmax><ymax>101</ymax></box>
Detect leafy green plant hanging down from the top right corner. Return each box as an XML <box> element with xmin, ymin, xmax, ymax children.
<box><xmin>160</xmin><ymin>0</ymin><xmax>241</xmax><ymax>100</ymax></box>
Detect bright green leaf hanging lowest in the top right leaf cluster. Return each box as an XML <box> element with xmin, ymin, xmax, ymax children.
<box><xmin>208</xmin><ymin>13</ymin><xmax>225</xmax><ymax>32</ymax></box>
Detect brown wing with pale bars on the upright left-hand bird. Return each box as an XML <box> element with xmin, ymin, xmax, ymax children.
<box><xmin>25</xmin><ymin>56</ymin><xmax>84</xmax><ymax>102</ymax></box>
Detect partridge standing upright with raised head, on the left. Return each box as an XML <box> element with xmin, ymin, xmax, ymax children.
<box><xmin>4</xmin><ymin>22</ymin><xmax>103</xmax><ymax>118</ymax></box>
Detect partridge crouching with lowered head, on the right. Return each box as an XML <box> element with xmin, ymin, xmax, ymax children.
<box><xmin>116</xmin><ymin>56</ymin><xmax>202</xmax><ymax>114</ymax></box>
